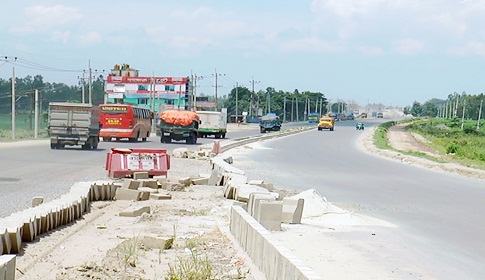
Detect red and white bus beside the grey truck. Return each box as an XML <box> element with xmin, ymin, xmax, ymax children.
<box><xmin>99</xmin><ymin>104</ymin><xmax>154</xmax><ymax>142</ymax></box>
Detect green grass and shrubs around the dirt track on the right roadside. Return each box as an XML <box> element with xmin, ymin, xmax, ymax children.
<box><xmin>374</xmin><ymin>118</ymin><xmax>485</xmax><ymax>169</ymax></box>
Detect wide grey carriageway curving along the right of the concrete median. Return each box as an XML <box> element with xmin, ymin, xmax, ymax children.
<box><xmin>229</xmin><ymin>120</ymin><xmax>485</xmax><ymax>279</ymax></box>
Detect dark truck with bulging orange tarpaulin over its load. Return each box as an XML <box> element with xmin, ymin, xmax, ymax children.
<box><xmin>155</xmin><ymin>110</ymin><xmax>200</xmax><ymax>144</ymax></box>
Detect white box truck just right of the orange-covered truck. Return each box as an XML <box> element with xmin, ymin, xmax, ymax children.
<box><xmin>196</xmin><ymin>108</ymin><xmax>227</xmax><ymax>139</ymax></box>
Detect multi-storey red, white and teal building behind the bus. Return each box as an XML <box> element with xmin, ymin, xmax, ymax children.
<box><xmin>104</xmin><ymin>64</ymin><xmax>194</xmax><ymax>112</ymax></box>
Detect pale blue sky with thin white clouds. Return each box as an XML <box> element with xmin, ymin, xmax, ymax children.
<box><xmin>0</xmin><ymin>0</ymin><xmax>485</xmax><ymax>107</ymax></box>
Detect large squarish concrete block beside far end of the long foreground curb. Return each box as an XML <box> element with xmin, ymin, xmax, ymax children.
<box><xmin>254</xmin><ymin>200</ymin><xmax>283</xmax><ymax>230</ymax></box>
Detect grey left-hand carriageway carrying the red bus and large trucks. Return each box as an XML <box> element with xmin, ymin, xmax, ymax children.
<box><xmin>0</xmin><ymin>122</ymin><xmax>308</xmax><ymax>217</ymax></box>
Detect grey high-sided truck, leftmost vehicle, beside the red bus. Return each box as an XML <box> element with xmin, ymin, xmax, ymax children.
<box><xmin>48</xmin><ymin>102</ymin><xmax>100</xmax><ymax>150</ymax></box>
